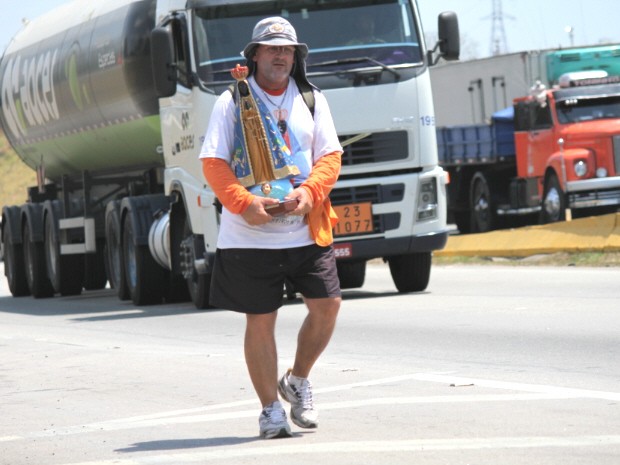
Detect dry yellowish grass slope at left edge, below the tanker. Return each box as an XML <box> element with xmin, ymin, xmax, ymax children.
<box><xmin>0</xmin><ymin>129</ymin><xmax>37</xmax><ymax>206</ymax></box>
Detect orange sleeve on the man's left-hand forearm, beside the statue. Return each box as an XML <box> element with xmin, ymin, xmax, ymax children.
<box><xmin>202</xmin><ymin>158</ymin><xmax>254</xmax><ymax>214</ymax></box>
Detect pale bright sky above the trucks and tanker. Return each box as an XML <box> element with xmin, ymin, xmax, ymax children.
<box><xmin>0</xmin><ymin>0</ymin><xmax>620</xmax><ymax>59</ymax></box>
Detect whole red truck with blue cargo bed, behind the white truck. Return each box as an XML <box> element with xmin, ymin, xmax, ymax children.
<box><xmin>437</xmin><ymin>66</ymin><xmax>620</xmax><ymax>233</ymax></box>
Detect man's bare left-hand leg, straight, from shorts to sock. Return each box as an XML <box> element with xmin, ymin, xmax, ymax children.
<box><xmin>244</xmin><ymin>311</ymin><xmax>278</xmax><ymax>407</ymax></box>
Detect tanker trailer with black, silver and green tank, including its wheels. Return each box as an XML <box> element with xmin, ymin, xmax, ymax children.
<box><xmin>0</xmin><ymin>0</ymin><xmax>216</xmax><ymax>308</ymax></box>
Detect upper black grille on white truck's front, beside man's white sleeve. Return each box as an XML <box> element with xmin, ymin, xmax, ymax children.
<box><xmin>339</xmin><ymin>131</ymin><xmax>408</xmax><ymax>166</ymax></box>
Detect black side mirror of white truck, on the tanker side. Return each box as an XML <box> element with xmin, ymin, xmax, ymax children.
<box><xmin>151</xmin><ymin>27</ymin><xmax>177</xmax><ymax>98</ymax></box>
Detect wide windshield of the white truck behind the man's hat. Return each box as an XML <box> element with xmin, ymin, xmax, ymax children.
<box><xmin>193</xmin><ymin>0</ymin><xmax>423</xmax><ymax>90</ymax></box>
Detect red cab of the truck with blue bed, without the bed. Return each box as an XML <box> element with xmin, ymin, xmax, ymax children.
<box><xmin>514</xmin><ymin>72</ymin><xmax>620</xmax><ymax>222</ymax></box>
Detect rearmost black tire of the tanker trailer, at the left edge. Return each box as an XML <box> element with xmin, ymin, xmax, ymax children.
<box><xmin>2</xmin><ymin>207</ymin><xmax>30</xmax><ymax>297</ymax></box>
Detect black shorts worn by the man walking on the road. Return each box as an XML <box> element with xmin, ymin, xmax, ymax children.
<box><xmin>209</xmin><ymin>244</ymin><xmax>341</xmax><ymax>314</ymax></box>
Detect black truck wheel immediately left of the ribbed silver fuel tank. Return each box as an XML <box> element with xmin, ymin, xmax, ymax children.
<box><xmin>123</xmin><ymin>212</ymin><xmax>165</xmax><ymax>305</ymax></box>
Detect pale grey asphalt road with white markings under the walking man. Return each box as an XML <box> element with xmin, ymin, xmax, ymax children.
<box><xmin>0</xmin><ymin>265</ymin><xmax>620</xmax><ymax>465</ymax></box>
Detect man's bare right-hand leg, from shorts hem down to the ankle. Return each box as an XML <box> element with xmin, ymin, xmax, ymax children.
<box><xmin>291</xmin><ymin>297</ymin><xmax>341</xmax><ymax>378</ymax></box>
